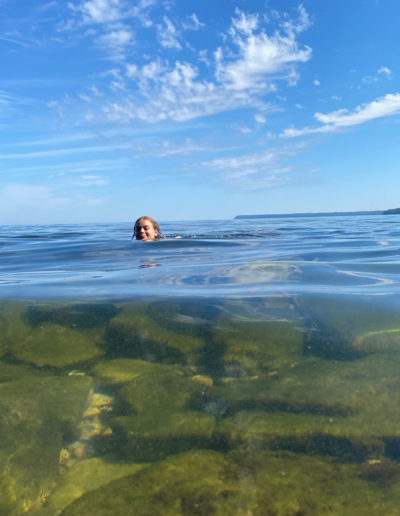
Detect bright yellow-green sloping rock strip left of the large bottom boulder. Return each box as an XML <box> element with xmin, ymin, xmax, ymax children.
<box><xmin>29</xmin><ymin>457</ymin><xmax>144</xmax><ymax>516</ymax></box>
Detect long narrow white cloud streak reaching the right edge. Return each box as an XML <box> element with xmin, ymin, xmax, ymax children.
<box><xmin>281</xmin><ymin>93</ymin><xmax>400</xmax><ymax>137</ymax></box>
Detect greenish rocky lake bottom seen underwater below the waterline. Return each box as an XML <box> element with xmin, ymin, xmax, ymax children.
<box><xmin>0</xmin><ymin>296</ymin><xmax>400</xmax><ymax>516</ymax></box>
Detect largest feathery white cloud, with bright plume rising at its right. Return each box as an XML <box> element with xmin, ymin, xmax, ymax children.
<box><xmin>98</xmin><ymin>8</ymin><xmax>311</xmax><ymax>123</ymax></box>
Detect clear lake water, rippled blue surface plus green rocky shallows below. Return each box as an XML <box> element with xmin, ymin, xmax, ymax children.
<box><xmin>0</xmin><ymin>215</ymin><xmax>400</xmax><ymax>516</ymax></box>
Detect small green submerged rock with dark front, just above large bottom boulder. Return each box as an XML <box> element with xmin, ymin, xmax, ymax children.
<box><xmin>110</xmin><ymin>411</ymin><xmax>215</xmax><ymax>462</ymax></box>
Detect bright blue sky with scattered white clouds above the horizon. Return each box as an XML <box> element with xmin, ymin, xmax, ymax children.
<box><xmin>0</xmin><ymin>0</ymin><xmax>400</xmax><ymax>224</ymax></box>
